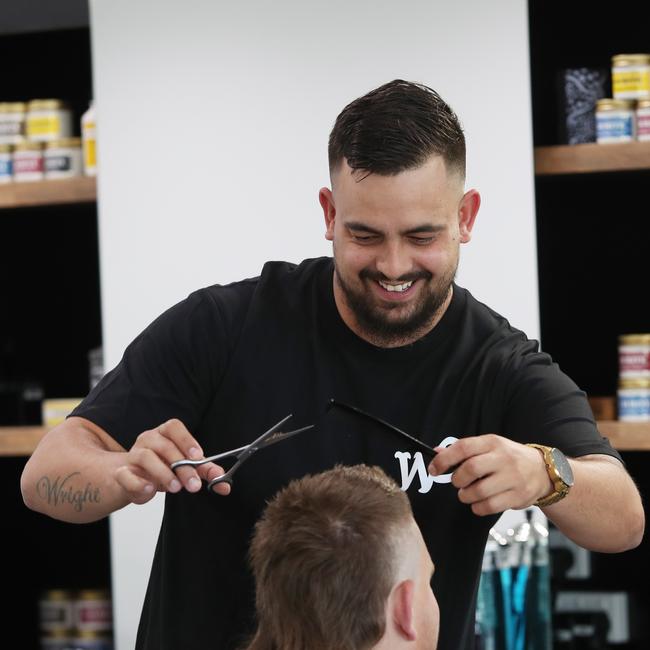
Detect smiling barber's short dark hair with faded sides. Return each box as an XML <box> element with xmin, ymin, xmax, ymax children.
<box><xmin>328</xmin><ymin>79</ymin><xmax>465</xmax><ymax>178</ymax></box>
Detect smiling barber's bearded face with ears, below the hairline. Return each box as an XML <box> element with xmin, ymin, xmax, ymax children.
<box><xmin>320</xmin><ymin>156</ymin><xmax>478</xmax><ymax>347</ymax></box>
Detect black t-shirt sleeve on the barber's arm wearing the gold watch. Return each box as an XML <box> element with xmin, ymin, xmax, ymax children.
<box><xmin>496</xmin><ymin>340</ymin><xmax>622</xmax><ymax>461</ymax></box>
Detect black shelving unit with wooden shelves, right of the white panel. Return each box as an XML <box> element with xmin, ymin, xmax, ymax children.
<box><xmin>528</xmin><ymin>0</ymin><xmax>650</xmax><ymax>650</ymax></box>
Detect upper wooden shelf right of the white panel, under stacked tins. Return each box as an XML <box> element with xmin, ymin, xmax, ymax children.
<box><xmin>535</xmin><ymin>142</ymin><xmax>650</xmax><ymax>176</ymax></box>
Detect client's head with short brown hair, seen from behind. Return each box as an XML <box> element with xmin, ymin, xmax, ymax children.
<box><xmin>249</xmin><ymin>465</ymin><xmax>438</xmax><ymax>650</ymax></box>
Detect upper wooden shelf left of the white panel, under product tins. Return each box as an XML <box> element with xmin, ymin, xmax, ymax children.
<box><xmin>0</xmin><ymin>176</ymin><xmax>97</xmax><ymax>209</ymax></box>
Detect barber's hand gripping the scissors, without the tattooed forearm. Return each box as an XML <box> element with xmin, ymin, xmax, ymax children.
<box><xmin>114</xmin><ymin>419</ymin><xmax>230</xmax><ymax>503</ymax></box>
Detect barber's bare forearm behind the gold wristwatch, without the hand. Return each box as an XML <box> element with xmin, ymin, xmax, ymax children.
<box><xmin>543</xmin><ymin>457</ymin><xmax>645</xmax><ymax>553</ymax></box>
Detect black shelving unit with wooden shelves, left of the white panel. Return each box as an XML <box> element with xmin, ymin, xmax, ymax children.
<box><xmin>0</xmin><ymin>11</ymin><xmax>111</xmax><ymax>650</ymax></box>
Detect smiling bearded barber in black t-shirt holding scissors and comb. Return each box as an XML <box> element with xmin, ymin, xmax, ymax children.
<box><xmin>21</xmin><ymin>80</ymin><xmax>645</xmax><ymax>650</ymax></box>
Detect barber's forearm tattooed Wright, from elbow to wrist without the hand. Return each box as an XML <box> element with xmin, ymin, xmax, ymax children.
<box><xmin>20</xmin><ymin>421</ymin><xmax>128</xmax><ymax>523</ymax></box>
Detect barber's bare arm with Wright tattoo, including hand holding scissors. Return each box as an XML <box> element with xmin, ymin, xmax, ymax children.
<box><xmin>20</xmin><ymin>417</ymin><xmax>230</xmax><ymax>523</ymax></box>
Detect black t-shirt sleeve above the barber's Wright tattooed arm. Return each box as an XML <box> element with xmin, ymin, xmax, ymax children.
<box><xmin>70</xmin><ymin>289</ymin><xmax>229</xmax><ymax>449</ymax></box>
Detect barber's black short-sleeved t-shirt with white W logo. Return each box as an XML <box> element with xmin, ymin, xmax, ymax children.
<box><xmin>73</xmin><ymin>258</ymin><xmax>618</xmax><ymax>650</ymax></box>
